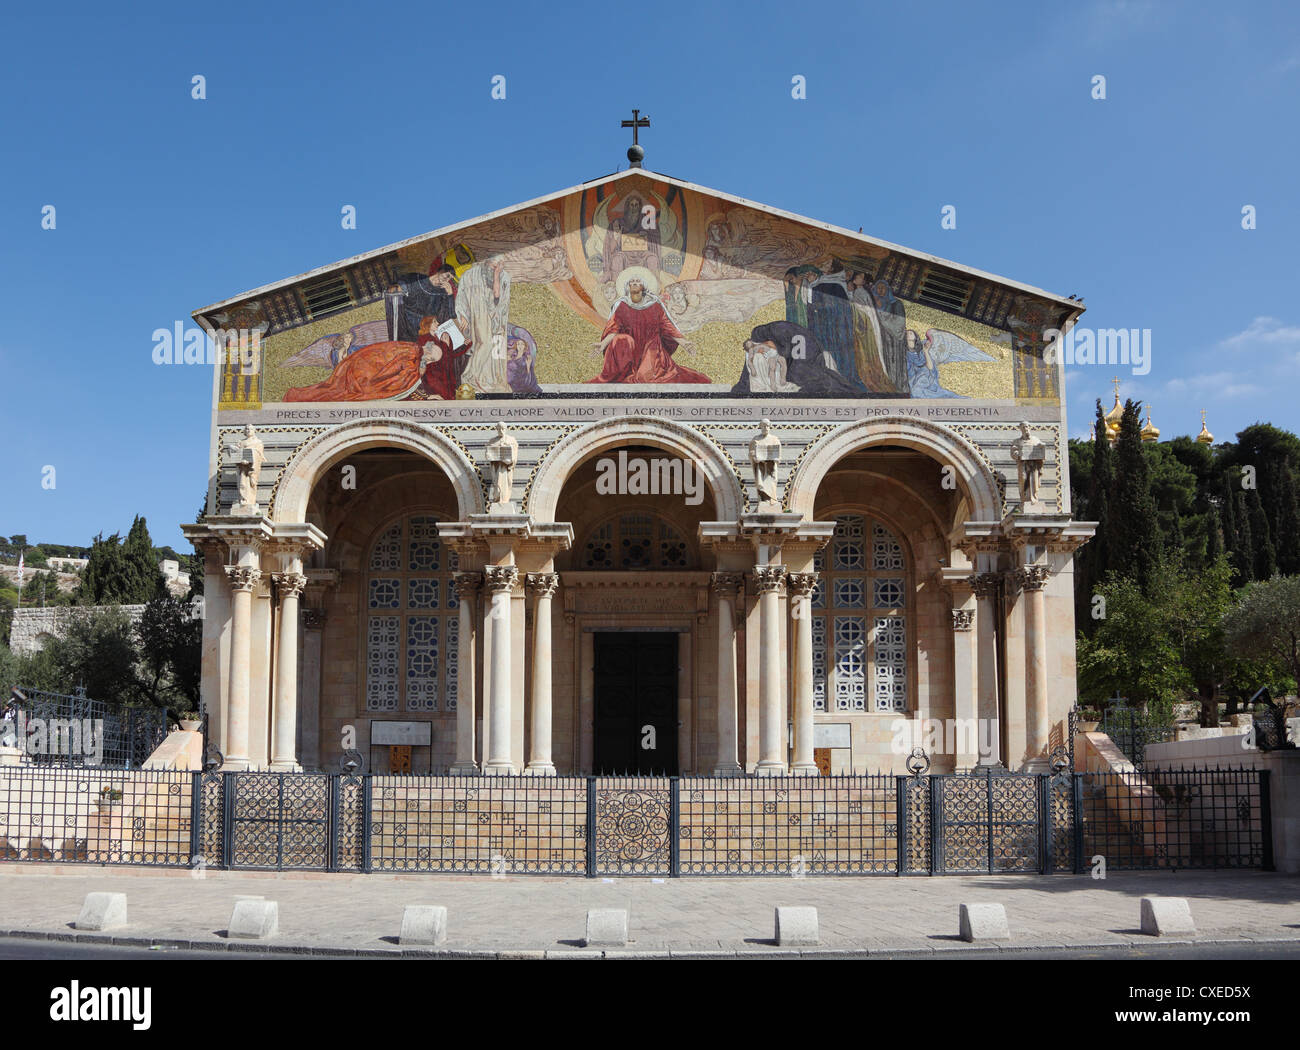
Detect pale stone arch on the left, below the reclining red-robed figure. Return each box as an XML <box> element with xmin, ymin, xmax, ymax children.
<box><xmin>269</xmin><ymin>418</ymin><xmax>486</xmax><ymax>522</ymax></box>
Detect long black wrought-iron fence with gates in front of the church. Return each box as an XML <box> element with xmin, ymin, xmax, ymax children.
<box><xmin>0</xmin><ymin>765</ymin><xmax>1273</xmax><ymax>877</ymax></box>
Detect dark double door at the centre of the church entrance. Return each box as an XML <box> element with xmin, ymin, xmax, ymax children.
<box><xmin>592</xmin><ymin>630</ymin><xmax>677</xmax><ymax>776</ymax></box>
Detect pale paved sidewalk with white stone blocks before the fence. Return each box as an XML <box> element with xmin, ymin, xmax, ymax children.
<box><xmin>0</xmin><ymin>864</ymin><xmax>1300</xmax><ymax>956</ymax></box>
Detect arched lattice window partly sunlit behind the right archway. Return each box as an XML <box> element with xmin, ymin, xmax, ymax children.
<box><xmin>813</xmin><ymin>515</ymin><xmax>910</xmax><ymax>713</ymax></box>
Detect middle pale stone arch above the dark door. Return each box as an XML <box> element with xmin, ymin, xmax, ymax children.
<box><xmin>525</xmin><ymin>416</ymin><xmax>745</xmax><ymax>522</ymax></box>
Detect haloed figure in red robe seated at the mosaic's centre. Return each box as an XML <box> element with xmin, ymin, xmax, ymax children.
<box><xmin>588</xmin><ymin>277</ymin><xmax>712</xmax><ymax>383</ymax></box>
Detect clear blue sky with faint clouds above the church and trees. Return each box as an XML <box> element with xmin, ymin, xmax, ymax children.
<box><xmin>0</xmin><ymin>0</ymin><xmax>1300</xmax><ymax>550</ymax></box>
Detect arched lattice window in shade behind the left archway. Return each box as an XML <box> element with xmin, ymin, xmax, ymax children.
<box><xmin>364</xmin><ymin>515</ymin><xmax>459</xmax><ymax>712</ymax></box>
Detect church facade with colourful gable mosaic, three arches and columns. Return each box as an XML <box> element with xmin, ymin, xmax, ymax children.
<box><xmin>185</xmin><ymin>166</ymin><xmax>1092</xmax><ymax>776</ymax></box>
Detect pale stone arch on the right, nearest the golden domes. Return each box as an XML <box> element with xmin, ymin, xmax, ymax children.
<box><xmin>785</xmin><ymin>416</ymin><xmax>1002</xmax><ymax>521</ymax></box>
